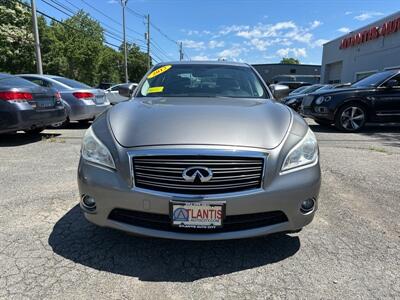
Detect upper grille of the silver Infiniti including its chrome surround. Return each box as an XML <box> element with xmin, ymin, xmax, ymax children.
<box><xmin>128</xmin><ymin>148</ymin><xmax>267</xmax><ymax>199</ymax></box>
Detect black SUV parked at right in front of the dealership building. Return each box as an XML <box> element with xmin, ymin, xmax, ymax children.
<box><xmin>301</xmin><ymin>70</ymin><xmax>400</xmax><ymax>132</ymax></box>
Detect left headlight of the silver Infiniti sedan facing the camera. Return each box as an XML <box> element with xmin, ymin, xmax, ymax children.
<box><xmin>81</xmin><ymin>127</ymin><xmax>115</xmax><ymax>169</ymax></box>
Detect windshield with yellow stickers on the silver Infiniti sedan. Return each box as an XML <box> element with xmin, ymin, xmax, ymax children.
<box><xmin>137</xmin><ymin>64</ymin><xmax>267</xmax><ymax>98</ymax></box>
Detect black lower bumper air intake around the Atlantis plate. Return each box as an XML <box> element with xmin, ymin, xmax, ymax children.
<box><xmin>108</xmin><ymin>208</ymin><xmax>288</xmax><ymax>233</ymax></box>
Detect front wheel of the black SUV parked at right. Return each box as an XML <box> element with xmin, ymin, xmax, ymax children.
<box><xmin>335</xmin><ymin>103</ymin><xmax>367</xmax><ymax>132</ymax></box>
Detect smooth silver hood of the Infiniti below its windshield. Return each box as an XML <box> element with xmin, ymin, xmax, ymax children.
<box><xmin>109</xmin><ymin>97</ymin><xmax>292</xmax><ymax>149</ymax></box>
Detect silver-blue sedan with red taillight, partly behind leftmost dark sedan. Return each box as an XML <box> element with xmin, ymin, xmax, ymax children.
<box><xmin>18</xmin><ymin>74</ymin><xmax>110</xmax><ymax>127</ymax></box>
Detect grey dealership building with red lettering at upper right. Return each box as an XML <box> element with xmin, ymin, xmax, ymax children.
<box><xmin>321</xmin><ymin>12</ymin><xmax>400</xmax><ymax>83</ymax></box>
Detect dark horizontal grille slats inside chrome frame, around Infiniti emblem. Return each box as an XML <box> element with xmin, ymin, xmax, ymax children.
<box><xmin>132</xmin><ymin>155</ymin><xmax>264</xmax><ymax>195</ymax></box>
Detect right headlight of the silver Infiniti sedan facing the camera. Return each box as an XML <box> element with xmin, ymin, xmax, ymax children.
<box><xmin>282</xmin><ymin>129</ymin><xmax>318</xmax><ymax>171</ymax></box>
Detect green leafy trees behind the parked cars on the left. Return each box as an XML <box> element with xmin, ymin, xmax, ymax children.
<box><xmin>0</xmin><ymin>0</ymin><xmax>147</xmax><ymax>86</ymax></box>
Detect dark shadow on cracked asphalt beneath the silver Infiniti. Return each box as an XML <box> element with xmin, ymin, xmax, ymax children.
<box><xmin>49</xmin><ymin>205</ymin><xmax>300</xmax><ymax>282</ymax></box>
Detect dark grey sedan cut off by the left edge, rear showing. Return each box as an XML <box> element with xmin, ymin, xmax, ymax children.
<box><xmin>0</xmin><ymin>73</ymin><xmax>66</xmax><ymax>134</ymax></box>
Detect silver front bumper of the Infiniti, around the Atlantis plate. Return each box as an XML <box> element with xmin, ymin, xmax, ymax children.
<box><xmin>78</xmin><ymin>152</ymin><xmax>321</xmax><ymax>240</ymax></box>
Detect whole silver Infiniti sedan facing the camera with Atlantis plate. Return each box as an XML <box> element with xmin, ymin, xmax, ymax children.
<box><xmin>78</xmin><ymin>62</ymin><xmax>321</xmax><ymax>240</ymax></box>
